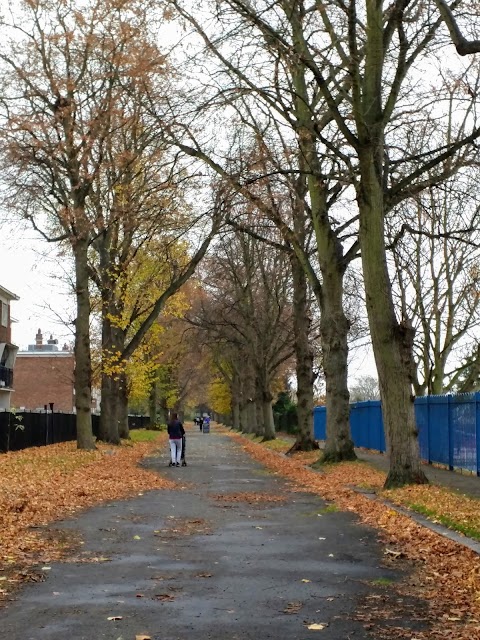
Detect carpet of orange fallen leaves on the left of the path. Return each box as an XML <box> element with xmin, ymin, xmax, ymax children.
<box><xmin>0</xmin><ymin>434</ymin><xmax>178</xmax><ymax>597</ymax></box>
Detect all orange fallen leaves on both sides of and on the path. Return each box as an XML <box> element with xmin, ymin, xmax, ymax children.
<box><xmin>0</xmin><ymin>422</ymin><xmax>480</xmax><ymax>640</ymax></box>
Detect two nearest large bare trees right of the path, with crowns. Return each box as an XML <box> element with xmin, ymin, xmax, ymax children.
<box><xmin>163</xmin><ymin>0</ymin><xmax>480</xmax><ymax>486</ymax></box>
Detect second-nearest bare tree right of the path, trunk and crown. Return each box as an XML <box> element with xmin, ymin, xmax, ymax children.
<box><xmin>162</xmin><ymin>2</ymin><xmax>357</xmax><ymax>461</ymax></box>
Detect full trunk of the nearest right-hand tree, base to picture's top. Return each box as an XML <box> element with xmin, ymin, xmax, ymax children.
<box><xmin>354</xmin><ymin>1</ymin><xmax>427</xmax><ymax>488</ymax></box>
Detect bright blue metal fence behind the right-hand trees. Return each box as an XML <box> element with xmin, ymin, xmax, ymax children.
<box><xmin>313</xmin><ymin>392</ymin><xmax>480</xmax><ymax>476</ymax></box>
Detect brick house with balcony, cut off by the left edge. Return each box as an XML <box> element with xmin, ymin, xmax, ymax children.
<box><xmin>0</xmin><ymin>286</ymin><xmax>19</xmax><ymax>409</ymax></box>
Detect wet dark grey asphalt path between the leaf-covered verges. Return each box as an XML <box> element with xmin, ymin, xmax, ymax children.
<box><xmin>0</xmin><ymin>430</ymin><xmax>425</xmax><ymax>640</ymax></box>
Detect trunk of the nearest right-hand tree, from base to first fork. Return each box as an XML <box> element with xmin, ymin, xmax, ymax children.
<box><xmin>359</xmin><ymin>153</ymin><xmax>428</xmax><ymax>488</ymax></box>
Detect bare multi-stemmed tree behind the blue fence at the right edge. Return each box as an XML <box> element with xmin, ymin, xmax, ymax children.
<box><xmin>387</xmin><ymin>168</ymin><xmax>480</xmax><ymax>395</ymax></box>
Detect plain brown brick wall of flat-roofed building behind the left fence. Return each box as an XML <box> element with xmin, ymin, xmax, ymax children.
<box><xmin>11</xmin><ymin>352</ymin><xmax>75</xmax><ymax>412</ymax></box>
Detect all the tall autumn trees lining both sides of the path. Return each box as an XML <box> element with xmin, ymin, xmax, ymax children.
<box><xmin>0</xmin><ymin>0</ymin><xmax>480</xmax><ymax>486</ymax></box>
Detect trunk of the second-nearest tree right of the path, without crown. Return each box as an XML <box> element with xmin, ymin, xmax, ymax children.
<box><xmin>289</xmin><ymin>33</ymin><xmax>356</xmax><ymax>462</ymax></box>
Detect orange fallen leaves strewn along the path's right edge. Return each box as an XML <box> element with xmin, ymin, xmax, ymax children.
<box><xmin>225</xmin><ymin>431</ymin><xmax>480</xmax><ymax>640</ymax></box>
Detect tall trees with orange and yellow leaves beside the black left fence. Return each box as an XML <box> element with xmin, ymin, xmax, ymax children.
<box><xmin>0</xmin><ymin>0</ymin><xmax>219</xmax><ymax>448</ymax></box>
